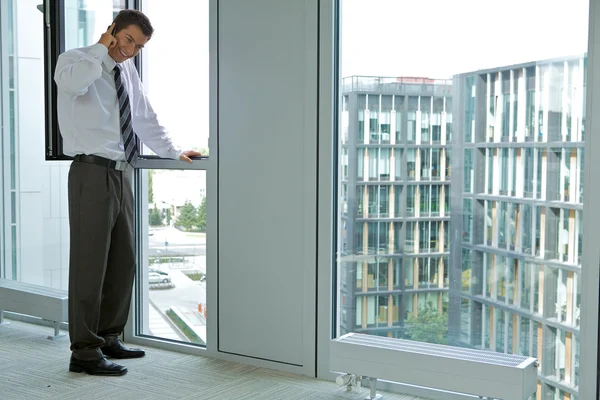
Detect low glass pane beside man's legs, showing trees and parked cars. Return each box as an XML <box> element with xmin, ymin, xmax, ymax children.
<box><xmin>140</xmin><ymin>169</ymin><xmax>207</xmax><ymax>345</ymax></box>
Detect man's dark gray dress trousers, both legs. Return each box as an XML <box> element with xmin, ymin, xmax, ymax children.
<box><xmin>68</xmin><ymin>161</ymin><xmax>135</xmax><ymax>360</ymax></box>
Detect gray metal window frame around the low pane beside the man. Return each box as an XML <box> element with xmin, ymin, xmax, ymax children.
<box><xmin>123</xmin><ymin>0</ymin><xmax>219</xmax><ymax>357</ymax></box>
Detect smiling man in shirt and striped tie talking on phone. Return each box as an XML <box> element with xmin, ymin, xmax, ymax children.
<box><xmin>54</xmin><ymin>10</ymin><xmax>201</xmax><ymax>376</ymax></box>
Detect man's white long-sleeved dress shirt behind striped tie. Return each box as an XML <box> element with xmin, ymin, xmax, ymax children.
<box><xmin>54</xmin><ymin>43</ymin><xmax>182</xmax><ymax>161</ymax></box>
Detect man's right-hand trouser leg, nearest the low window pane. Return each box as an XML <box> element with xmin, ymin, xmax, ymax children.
<box><xmin>98</xmin><ymin>171</ymin><xmax>135</xmax><ymax>344</ymax></box>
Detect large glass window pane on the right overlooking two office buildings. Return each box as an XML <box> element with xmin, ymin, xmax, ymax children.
<box><xmin>337</xmin><ymin>0</ymin><xmax>588</xmax><ymax>398</ymax></box>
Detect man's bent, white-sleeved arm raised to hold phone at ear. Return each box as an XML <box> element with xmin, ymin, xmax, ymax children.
<box><xmin>54</xmin><ymin>23</ymin><xmax>117</xmax><ymax>96</ymax></box>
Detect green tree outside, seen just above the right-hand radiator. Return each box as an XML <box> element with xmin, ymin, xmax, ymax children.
<box><xmin>405</xmin><ymin>302</ymin><xmax>448</xmax><ymax>344</ymax></box>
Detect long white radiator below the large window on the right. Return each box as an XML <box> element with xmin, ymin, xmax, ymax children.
<box><xmin>329</xmin><ymin>333</ymin><xmax>538</xmax><ymax>400</ymax></box>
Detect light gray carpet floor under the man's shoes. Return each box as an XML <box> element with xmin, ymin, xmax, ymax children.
<box><xmin>0</xmin><ymin>321</ymin><xmax>424</xmax><ymax>400</ymax></box>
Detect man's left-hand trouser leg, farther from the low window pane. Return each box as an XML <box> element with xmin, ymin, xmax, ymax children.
<box><xmin>68</xmin><ymin>162</ymin><xmax>118</xmax><ymax>361</ymax></box>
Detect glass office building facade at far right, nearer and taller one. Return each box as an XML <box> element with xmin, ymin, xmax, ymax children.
<box><xmin>458</xmin><ymin>61</ymin><xmax>585</xmax><ymax>398</ymax></box>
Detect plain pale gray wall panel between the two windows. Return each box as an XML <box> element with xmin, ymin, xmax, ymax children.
<box><xmin>218</xmin><ymin>0</ymin><xmax>318</xmax><ymax>374</ymax></box>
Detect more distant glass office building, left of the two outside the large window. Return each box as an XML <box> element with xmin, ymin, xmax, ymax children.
<box><xmin>340</xmin><ymin>84</ymin><xmax>452</xmax><ymax>343</ymax></box>
